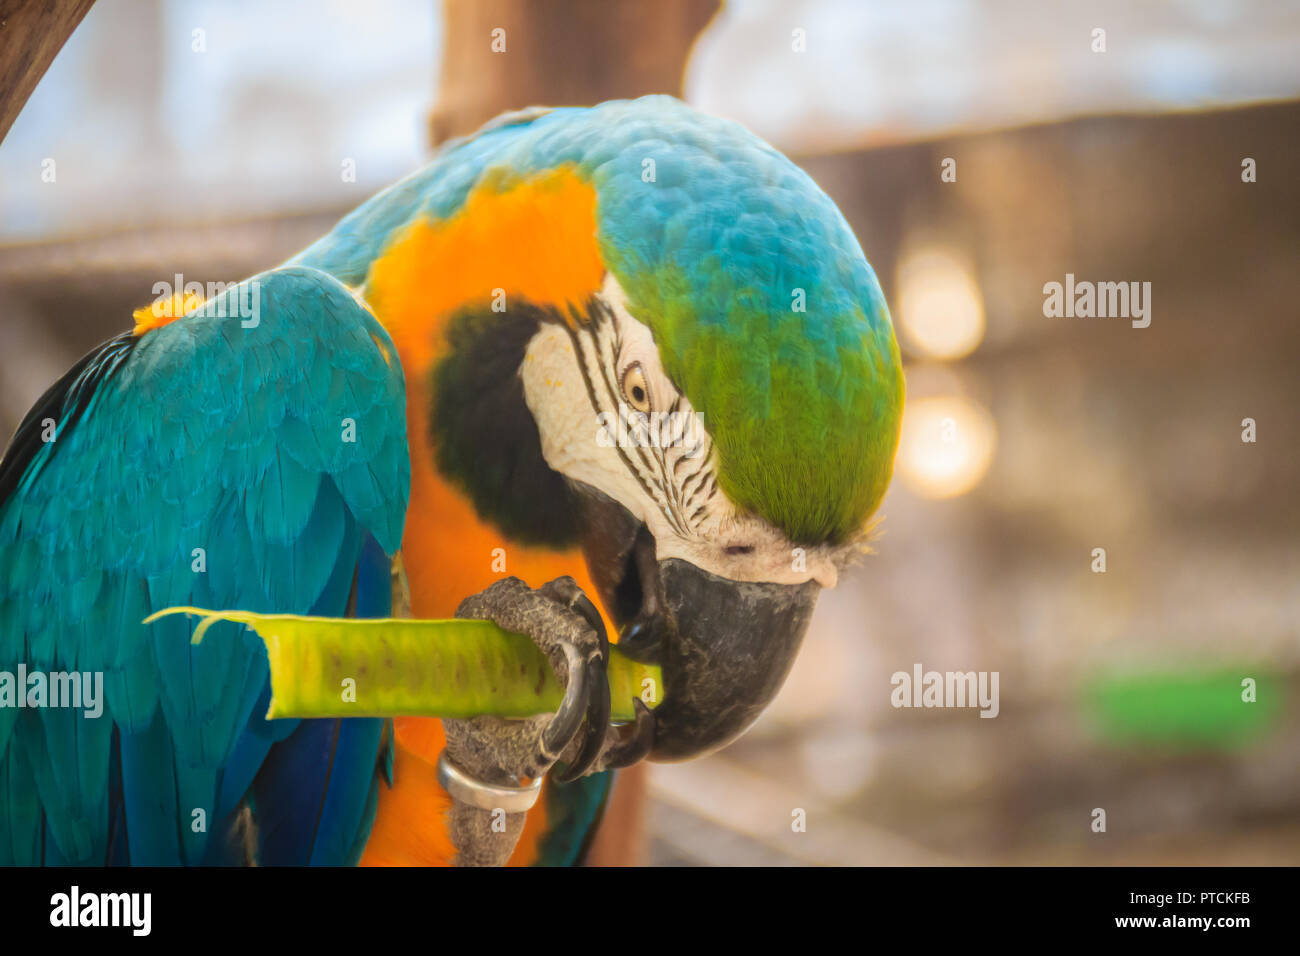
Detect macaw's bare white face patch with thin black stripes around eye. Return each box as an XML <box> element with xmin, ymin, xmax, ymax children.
<box><xmin>519</xmin><ymin>276</ymin><xmax>839</xmax><ymax>588</ymax></box>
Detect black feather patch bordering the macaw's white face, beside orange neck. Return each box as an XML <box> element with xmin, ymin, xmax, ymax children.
<box><xmin>429</xmin><ymin>300</ymin><xmax>579</xmax><ymax>549</ymax></box>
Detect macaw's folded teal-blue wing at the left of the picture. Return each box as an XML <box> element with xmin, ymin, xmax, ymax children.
<box><xmin>0</xmin><ymin>268</ymin><xmax>410</xmax><ymax>864</ymax></box>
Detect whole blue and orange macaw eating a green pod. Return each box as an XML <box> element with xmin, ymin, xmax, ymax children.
<box><xmin>0</xmin><ymin>96</ymin><xmax>904</xmax><ymax>865</ymax></box>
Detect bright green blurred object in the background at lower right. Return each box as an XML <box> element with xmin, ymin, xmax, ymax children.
<box><xmin>1083</xmin><ymin>666</ymin><xmax>1282</xmax><ymax>749</ymax></box>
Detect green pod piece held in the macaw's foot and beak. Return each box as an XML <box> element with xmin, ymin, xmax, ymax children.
<box><xmin>144</xmin><ymin>607</ymin><xmax>663</xmax><ymax>721</ymax></box>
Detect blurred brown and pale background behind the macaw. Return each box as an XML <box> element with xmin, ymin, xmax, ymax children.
<box><xmin>0</xmin><ymin>0</ymin><xmax>1300</xmax><ymax>865</ymax></box>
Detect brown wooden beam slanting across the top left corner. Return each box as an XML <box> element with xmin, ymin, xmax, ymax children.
<box><xmin>0</xmin><ymin>0</ymin><xmax>95</xmax><ymax>143</ymax></box>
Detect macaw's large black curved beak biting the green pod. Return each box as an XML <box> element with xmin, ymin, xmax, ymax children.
<box><xmin>580</xmin><ymin>488</ymin><xmax>819</xmax><ymax>761</ymax></box>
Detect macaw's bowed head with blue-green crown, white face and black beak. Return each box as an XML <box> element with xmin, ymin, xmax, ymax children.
<box><xmin>361</xmin><ymin>98</ymin><xmax>904</xmax><ymax>760</ymax></box>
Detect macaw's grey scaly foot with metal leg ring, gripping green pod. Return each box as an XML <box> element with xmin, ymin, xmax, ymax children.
<box><xmin>438</xmin><ymin>578</ymin><xmax>654</xmax><ymax>866</ymax></box>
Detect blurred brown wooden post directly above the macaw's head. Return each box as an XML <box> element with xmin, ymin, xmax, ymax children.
<box><xmin>429</xmin><ymin>0</ymin><xmax>722</xmax><ymax>144</ymax></box>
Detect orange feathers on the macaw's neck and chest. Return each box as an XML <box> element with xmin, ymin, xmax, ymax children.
<box><xmin>361</xmin><ymin>169</ymin><xmax>605</xmax><ymax>865</ymax></box>
